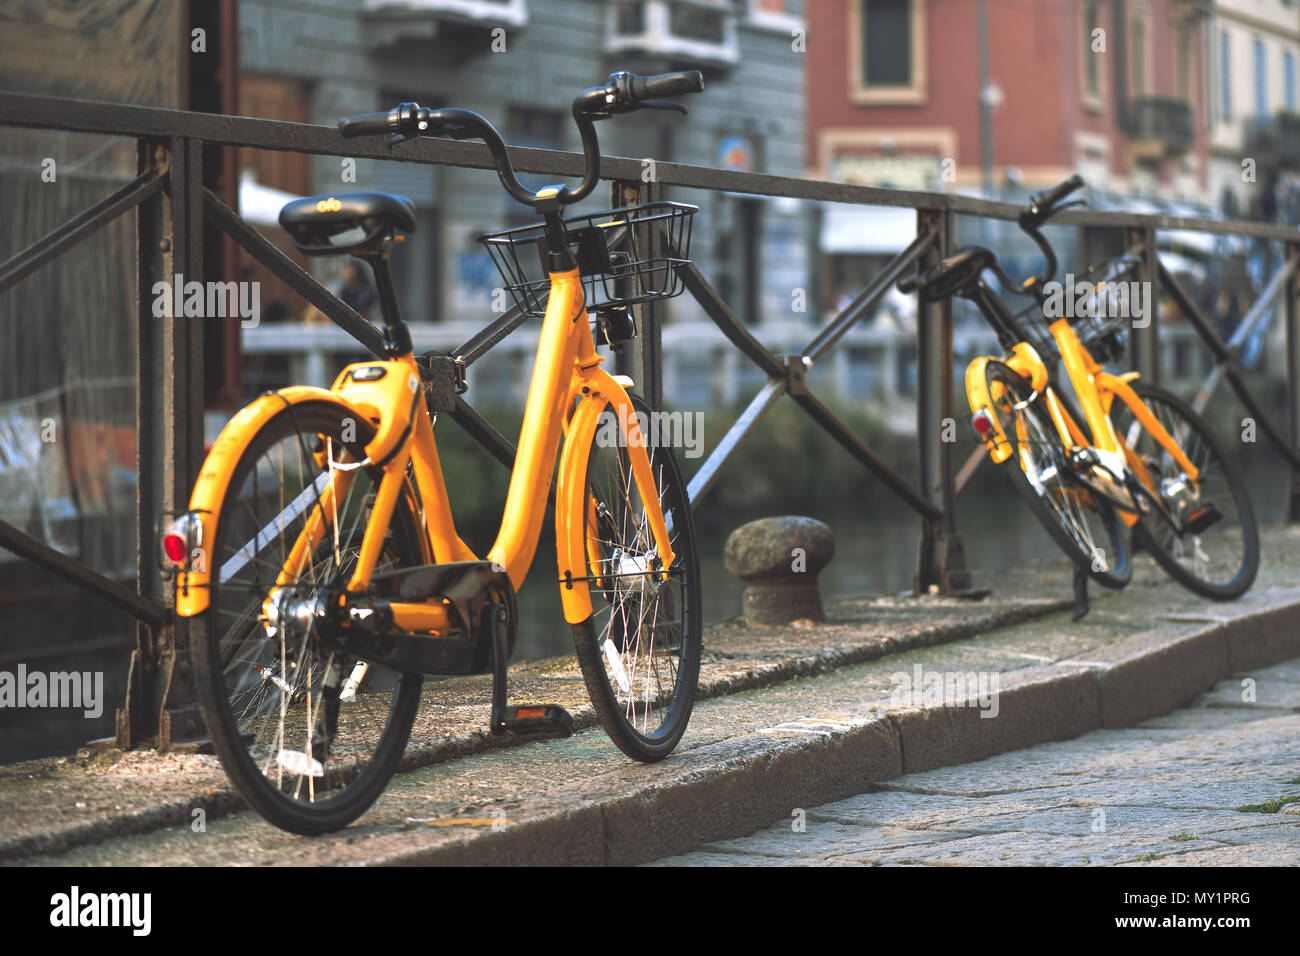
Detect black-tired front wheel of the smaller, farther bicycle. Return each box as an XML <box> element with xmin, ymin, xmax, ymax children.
<box><xmin>1113</xmin><ymin>382</ymin><xmax>1260</xmax><ymax>601</ymax></box>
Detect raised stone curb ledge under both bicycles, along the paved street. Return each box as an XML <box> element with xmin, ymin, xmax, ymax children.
<box><xmin>0</xmin><ymin>532</ymin><xmax>1300</xmax><ymax>866</ymax></box>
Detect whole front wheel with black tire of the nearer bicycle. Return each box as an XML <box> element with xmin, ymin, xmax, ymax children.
<box><xmin>573</xmin><ymin>397</ymin><xmax>703</xmax><ymax>762</ymax></box>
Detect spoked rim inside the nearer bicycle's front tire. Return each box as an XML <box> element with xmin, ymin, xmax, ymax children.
<box><xmin>586</xmin><ymin>408</ymin><xmax>692</xmax><ymax>743</ymax></box>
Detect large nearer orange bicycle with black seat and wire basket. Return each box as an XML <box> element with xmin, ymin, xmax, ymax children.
<box><xmin>161</xmin><ymin>72</ymin><xmax>702</xmax><ymax>834</ymax></box>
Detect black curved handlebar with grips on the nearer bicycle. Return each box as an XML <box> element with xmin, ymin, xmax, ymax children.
<box><xmin>338</xmin><ymin>70</ymin><xmax>705</xmax><ymax>208</ymax></box>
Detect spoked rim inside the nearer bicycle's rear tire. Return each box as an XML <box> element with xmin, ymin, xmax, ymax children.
<box><xmin>211</xmin><ymin>416</ymin><xmax>413</xmax><ymax>808</ymax></box>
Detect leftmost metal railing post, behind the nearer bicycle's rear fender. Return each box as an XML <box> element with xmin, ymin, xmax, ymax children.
<box><xmin>117</xmin><ymin>138</ymin><xmax>203</xmax><ymax>749</ymax></box>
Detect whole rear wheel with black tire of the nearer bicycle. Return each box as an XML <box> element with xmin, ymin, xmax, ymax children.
<box><xmin>191</xmin><ymin>402</ymin><xmax>423</xmax><ymax>834</ymax></box>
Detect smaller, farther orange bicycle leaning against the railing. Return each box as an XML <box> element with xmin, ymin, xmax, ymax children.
<box><xmin>898</xmin><ymin>176</ymin><xmax>1260</xmax><ymax>617</ymax></box>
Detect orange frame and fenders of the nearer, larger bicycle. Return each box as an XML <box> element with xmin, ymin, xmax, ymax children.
<box><xmin>177</xmin><ymin>269</ymin><xmax>675</xmax><ymax>632</ymax></box>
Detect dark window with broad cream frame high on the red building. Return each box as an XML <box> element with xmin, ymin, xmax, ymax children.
<box><xmin>849</xmin><ymin>0</ymin><xmax>926</xmax><ymax>103</ymax></box>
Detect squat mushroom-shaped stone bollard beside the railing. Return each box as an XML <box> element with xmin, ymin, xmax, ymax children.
<box><xmin>724</xmin><ymin>516</ymin><xmax>835</xmax><ymax>624</ymax></box>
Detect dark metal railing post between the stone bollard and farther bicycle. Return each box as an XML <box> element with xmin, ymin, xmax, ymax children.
<box><xmin>913</xmin><ymin>209</ymin><xmax>971</xmax><ymax>594</ymax></box>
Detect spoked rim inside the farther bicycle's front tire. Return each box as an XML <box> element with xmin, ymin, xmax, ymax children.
<box><xmin>1115</xmin><ymin>392</ymin><xmax>1248</xmax><ymax>588</ymax></box>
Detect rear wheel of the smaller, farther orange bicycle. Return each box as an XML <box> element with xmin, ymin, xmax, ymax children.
<box><xmin>984</xmin><ymin>362</ymin><xmax>1132</xmax><ymax>589</ymax></box>
